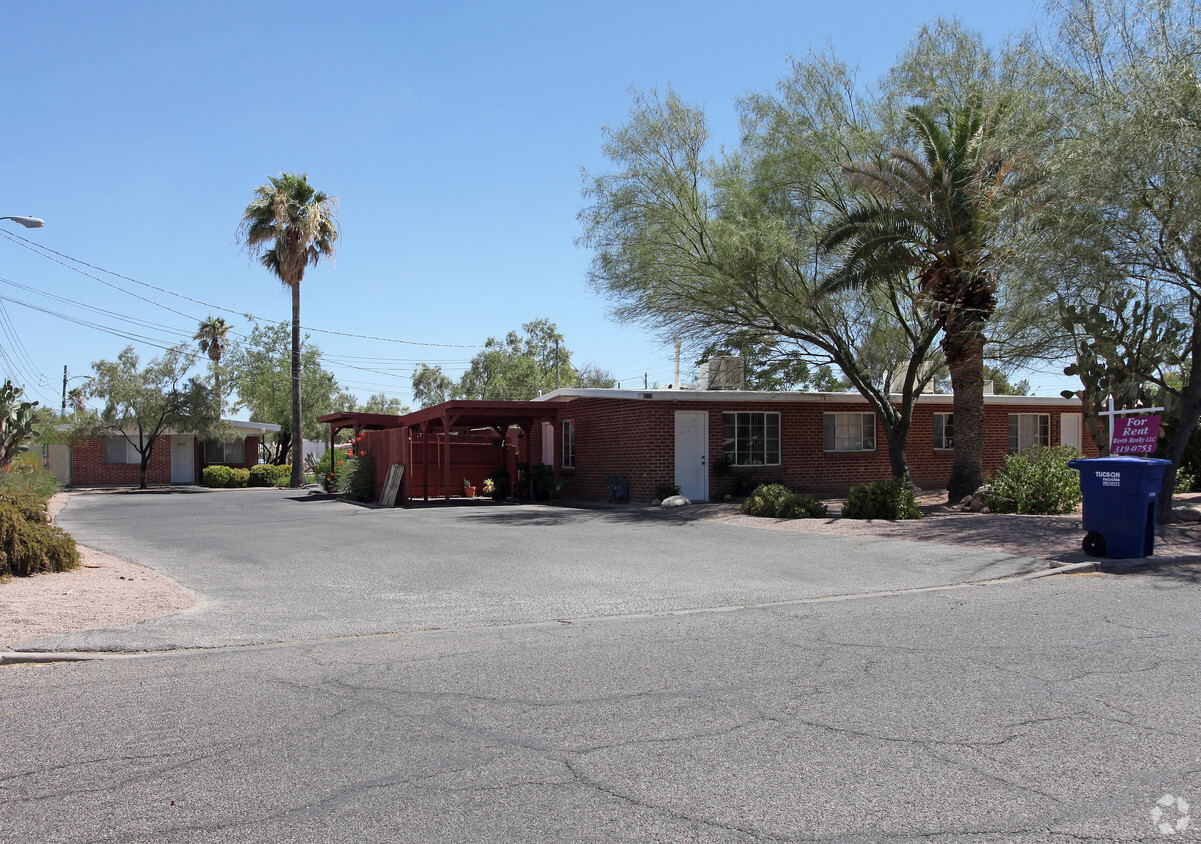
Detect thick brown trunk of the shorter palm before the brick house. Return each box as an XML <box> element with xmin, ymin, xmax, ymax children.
<box><xmin>943</xmin><ymin>319</ymin><xmax>985</xmax><ymax>504</ymax></box>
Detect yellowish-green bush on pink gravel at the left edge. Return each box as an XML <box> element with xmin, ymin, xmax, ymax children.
<box><xmin>0</xmin><ymin>490</ymin><xmax>79</xmax><ymax>577</ymax></box>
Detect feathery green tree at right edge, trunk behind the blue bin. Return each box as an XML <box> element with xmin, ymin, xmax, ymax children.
<box><xmin>1033</xmin><ymin>0</ymin><xmax>1201</xmax><ymax>521</ymax></box>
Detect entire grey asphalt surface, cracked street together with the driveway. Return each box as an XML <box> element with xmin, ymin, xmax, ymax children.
<box><xmin>0</xmin><ymin>485</ymin><xmax>1201</xmax><ymax>844</ymax></box>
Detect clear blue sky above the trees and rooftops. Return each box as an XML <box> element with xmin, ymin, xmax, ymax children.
<box><xmin>0</xmin><ymin>0</ymin><xmax>1066</xmax><ymax>405</ymax></box>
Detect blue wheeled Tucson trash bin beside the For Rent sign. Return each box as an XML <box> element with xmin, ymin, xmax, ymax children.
<box><xmin>1068</xmin><ymin>457</ymin><xmax>1171</xmax><ymax>559</ymax></box>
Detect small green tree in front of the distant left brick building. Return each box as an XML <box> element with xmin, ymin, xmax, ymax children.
<box><xmin>74</xmin><ymin>346</ymin><xmax>223</xmax><ymax>490</ymax></box>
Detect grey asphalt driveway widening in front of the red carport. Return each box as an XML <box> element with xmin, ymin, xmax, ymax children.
<box><xmin>18</xmin><ymin>490</ymin><xmax>1046</xmax><ymax>651</ymax></box>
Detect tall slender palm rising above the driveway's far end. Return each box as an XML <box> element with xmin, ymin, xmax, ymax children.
<box><xmin>239</xmin><ymin>173</ymin><xmax>340</xmax><ymax>487</ymax></box>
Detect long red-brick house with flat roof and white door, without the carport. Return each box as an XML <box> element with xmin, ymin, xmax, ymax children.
<box><xmin>531</xmin><ymin>389</ymin><xmax>1097</xmax><ymax>502</ymax></box>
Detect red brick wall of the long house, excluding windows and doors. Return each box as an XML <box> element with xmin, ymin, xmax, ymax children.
<box><xmin>552</xmin><ymin>396</ymin><xmax>1097</xmax><ymax>502</ymax></box>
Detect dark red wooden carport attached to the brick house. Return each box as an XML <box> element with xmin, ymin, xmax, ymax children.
<box><xmin>318</xmin><ymin>400</ymin><xmax>558</xmax><ymax>504</ymax></box>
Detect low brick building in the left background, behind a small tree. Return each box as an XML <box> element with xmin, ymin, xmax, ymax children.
<box><xmin>49</xmin><ymin>419</ymin><xmax>280</xmax><ymax>486</ymax></box>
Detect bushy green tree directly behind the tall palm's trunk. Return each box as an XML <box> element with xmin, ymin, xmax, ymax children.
<box><xmin>226</xmin><ymin>323</ymin><xmax>353</xmax><ymax>465</ymax></box>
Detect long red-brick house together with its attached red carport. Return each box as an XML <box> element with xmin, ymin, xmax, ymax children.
<box><xmin>345</xmin><ymin>388</ymin><xmax>1097</xmax><ymax>502</ymax></box>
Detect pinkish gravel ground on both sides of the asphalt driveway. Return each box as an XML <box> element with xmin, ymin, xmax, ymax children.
<box><xmin>0</xmin><ymin>491</ymin><xmax>1201</xmax><ymax>647</ymax></box>
